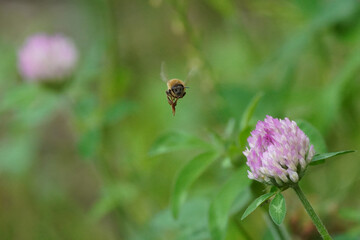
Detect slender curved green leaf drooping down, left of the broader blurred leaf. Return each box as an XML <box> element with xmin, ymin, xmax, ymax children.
<box><xmin>171</xmin><ymin>151</ymin><xmax>217</xmax><ymax>218</ymax></box>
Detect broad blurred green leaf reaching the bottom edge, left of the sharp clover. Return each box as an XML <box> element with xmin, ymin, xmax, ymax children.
<box><xmin>209</xmin><ymin>166</ymin><xmax>251</xmax><ymax>240</ymax></box>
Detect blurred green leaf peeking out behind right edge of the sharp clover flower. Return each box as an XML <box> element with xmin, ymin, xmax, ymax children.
<box><xmin>296</xmin><ymin>119</ymin><xmax>327</xmax><ymax>153</ymax></box>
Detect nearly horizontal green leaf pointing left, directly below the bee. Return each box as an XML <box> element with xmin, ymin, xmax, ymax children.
<box><xmin>149</xmin><ymin>132</ymin><xmax>212</xmax><ymax>156</ymax></box>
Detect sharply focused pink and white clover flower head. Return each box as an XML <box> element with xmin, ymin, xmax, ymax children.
<box><xmin>243</xmin><ymin>116</ymin><xmax>315</xmax><ymax>187</ymax></box>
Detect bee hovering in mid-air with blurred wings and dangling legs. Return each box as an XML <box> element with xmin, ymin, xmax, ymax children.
<box><xmin>160</xmin><ymin>63</ymin><xmax>193</xmax><ymax>116</ymax></box>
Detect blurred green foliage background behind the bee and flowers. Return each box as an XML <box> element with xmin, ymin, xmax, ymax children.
<box><xmin>0</xmin><ymin>0</ymin><xmax>360</xmax><ymax>240</ymax></box>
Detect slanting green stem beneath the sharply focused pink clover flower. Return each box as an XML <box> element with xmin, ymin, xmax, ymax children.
<box><xmin>293</xmin><ymin>184</ymin><xmax>332</xmax><ymax>240</ymax></box>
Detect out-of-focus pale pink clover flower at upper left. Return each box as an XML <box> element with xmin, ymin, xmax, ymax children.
<box><xmin>18</xmin><ymin>34</ymin><xmax>78</xmax><ymax>82</ymax></box>
